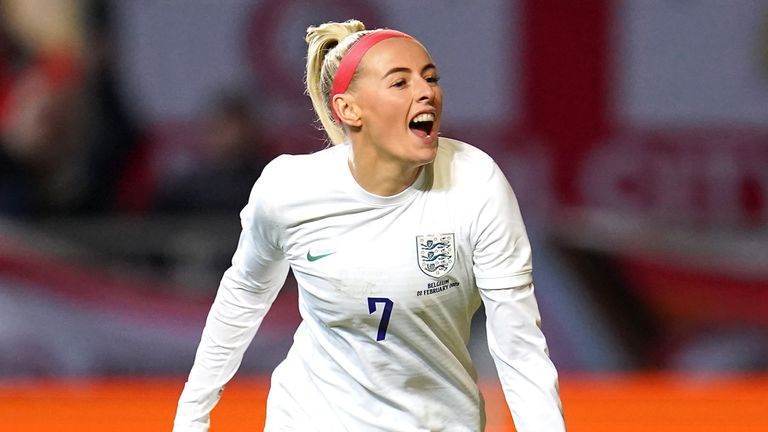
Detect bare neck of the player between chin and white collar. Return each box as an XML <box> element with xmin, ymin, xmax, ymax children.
<box><xmin>348</xmin><ymin>143</ymin><xmax>421</xmax><ymax>196</ymax></box>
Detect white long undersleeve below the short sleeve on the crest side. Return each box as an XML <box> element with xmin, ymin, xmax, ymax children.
<box><xmin>480</xmin><ymin>284</ymin><xmax>565</xmax><ymax>432</ymax></box>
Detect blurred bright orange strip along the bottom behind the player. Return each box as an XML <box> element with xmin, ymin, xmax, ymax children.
<box><xmin>0</xmin><ymin>374</ymin><xmax>768</xmax><ymax>432</ymax></box>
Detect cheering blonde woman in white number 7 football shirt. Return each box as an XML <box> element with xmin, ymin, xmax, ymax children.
<box><xmin>175</xmin><ymin>21</ymin><xmax>565</xmax><ymax>432</ymax></box>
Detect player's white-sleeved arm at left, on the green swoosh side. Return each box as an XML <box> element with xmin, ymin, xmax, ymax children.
<box><xmin>173</xmin><ymin>165</ymin><xmax>288</xmax><ymax>432</ymax></box>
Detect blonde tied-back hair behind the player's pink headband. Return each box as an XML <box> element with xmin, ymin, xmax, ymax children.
<box><xmin>305</xmin><ymin>20</ymin><xmax>369</xmax><ymax>145</ymax></box>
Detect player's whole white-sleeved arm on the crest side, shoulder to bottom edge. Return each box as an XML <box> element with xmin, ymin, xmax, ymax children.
<box><xmin>472</xmin><ymin>158</ymin><xmax>565</xmax><ymax>432</ymax></box>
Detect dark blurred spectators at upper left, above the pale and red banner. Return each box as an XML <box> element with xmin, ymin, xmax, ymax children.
<box><xmin>0</xmin><ymin>0</ymin><xmax>270</xmax><ymax>220</ymax></box>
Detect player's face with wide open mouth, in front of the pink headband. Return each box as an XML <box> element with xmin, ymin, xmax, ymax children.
<box><xmin>349</xmin><ymin>38</ymin><xmax>443</xmax><ymax>165</ymax></box>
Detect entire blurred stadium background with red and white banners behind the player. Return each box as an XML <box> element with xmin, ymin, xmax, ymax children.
<box><xmin>0</xmin><ymin>0</ymin><xmax>768</xmax><ymax>431</ymax></box>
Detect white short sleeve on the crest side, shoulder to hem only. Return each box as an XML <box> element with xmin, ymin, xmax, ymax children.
<box><xmin>471</xmin><ymin>163</ymin><xmax>533</xmax><ymax>289</ymax></box>
